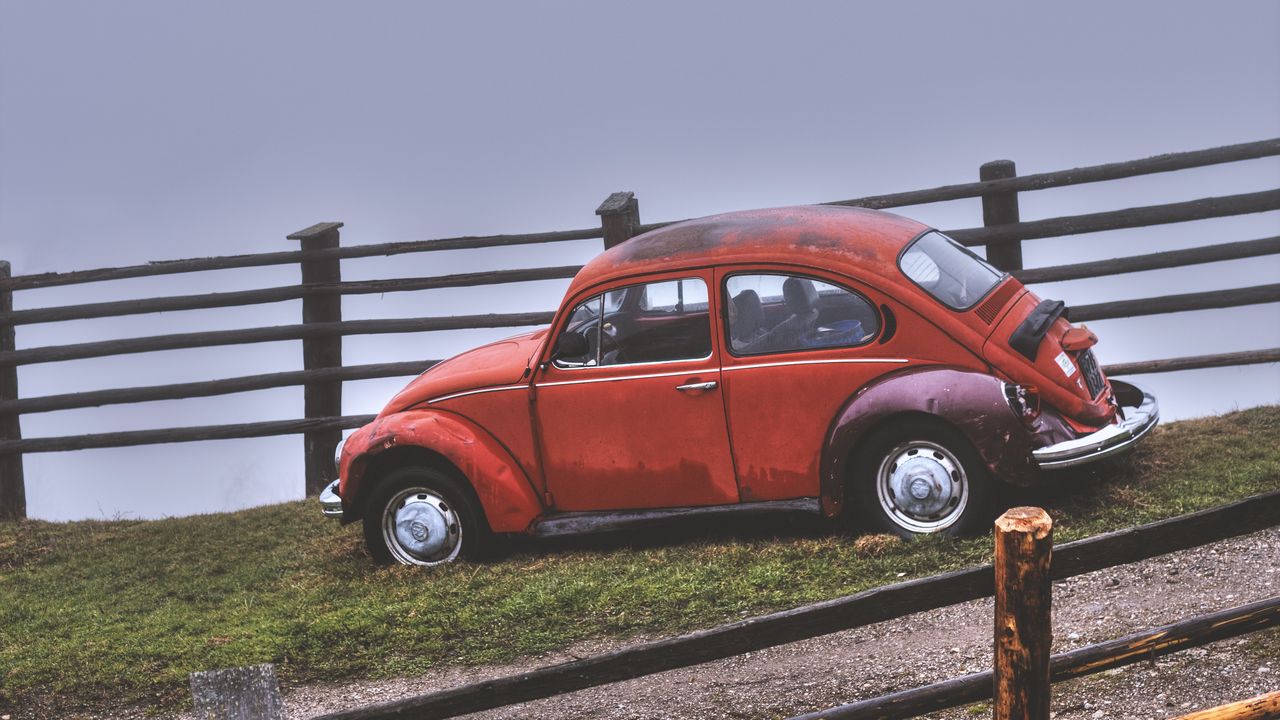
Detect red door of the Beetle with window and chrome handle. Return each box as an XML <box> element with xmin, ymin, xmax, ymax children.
<box><xmin>532</xmin><ymin>270</ymin><xmax>739</xmax><ymax>511</ymax></box>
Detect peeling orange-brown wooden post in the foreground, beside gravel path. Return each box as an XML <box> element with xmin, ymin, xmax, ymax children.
<box><xmin>992</xmin><ymin>507</ymin><xmax>1053</xmax><ymax>720</ymax></box>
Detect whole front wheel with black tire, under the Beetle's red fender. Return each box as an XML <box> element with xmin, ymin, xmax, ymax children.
<box><xmin>364</xmin><ymin>465</ymin><xmax>490</xmax><ymax>566</ymax></box>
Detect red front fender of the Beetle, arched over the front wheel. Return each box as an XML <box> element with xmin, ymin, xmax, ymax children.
<box><xmin>339</xmin><ymin>409</ymin><xmax>543</xmax><ymax>533</ymax></box>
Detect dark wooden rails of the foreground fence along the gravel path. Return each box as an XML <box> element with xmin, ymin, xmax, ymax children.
<box><xmin>285</xmin><ymin>491</ymin><xmax>1280</xmax><ymax>720</ymax></box>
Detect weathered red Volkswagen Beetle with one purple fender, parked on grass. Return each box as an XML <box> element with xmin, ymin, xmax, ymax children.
<box><xmin>320</xmin><ymin>206</ymin><xmax>1158</xmax><ymax>565</ymax></box>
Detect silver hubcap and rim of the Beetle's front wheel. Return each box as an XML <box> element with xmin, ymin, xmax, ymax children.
<box><xmin>383</xmin><ymin>488</ymin><xmax>462</xmax><ymax>565</ymax></box>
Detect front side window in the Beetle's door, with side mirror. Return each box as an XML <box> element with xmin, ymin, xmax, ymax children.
<box><xmin>556</xmin><ymin>272</ymin><xmax>712</xmax><ymax>368</ymax></box>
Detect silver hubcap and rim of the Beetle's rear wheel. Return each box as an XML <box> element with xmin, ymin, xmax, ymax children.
<box><xmin>876</xmin><ymin>439</ymin><xmax>969</xmax><ymax>533</ymax></box>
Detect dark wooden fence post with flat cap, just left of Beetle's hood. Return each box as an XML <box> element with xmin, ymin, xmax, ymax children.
<box><xmin>288</xmin><ymin>223</ymin><xmax>342</xmax><ymax>497</ymax></box>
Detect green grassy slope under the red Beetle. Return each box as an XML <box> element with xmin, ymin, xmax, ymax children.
<box><xmin>0</xmin><ymin>407</ymin><xmax>1280</xmax><ymax>711</ymax></box>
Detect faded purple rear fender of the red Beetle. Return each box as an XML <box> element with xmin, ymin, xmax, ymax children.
<box><xmin>819</xmin><ymin>365</ymin><xmax>1037</xmax><ymax>516</ymax></box>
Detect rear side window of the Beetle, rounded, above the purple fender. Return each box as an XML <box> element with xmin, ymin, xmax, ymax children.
<box><xmin>724</xmin><ymin>273</ymin><xmax>881</xmax><ymax>355</ymax></box>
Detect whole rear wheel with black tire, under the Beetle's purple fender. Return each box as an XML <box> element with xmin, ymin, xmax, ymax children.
<box><xmin>851</xmin><ymin>418</ymin><xmax>995</xmax><ymax>538</ymax></box>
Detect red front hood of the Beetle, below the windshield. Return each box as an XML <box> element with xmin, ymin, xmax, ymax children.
<box><xmin>379</xmin><ymin>328</ymin><xmax>547</xmax><ymax>418</ymax></box>
